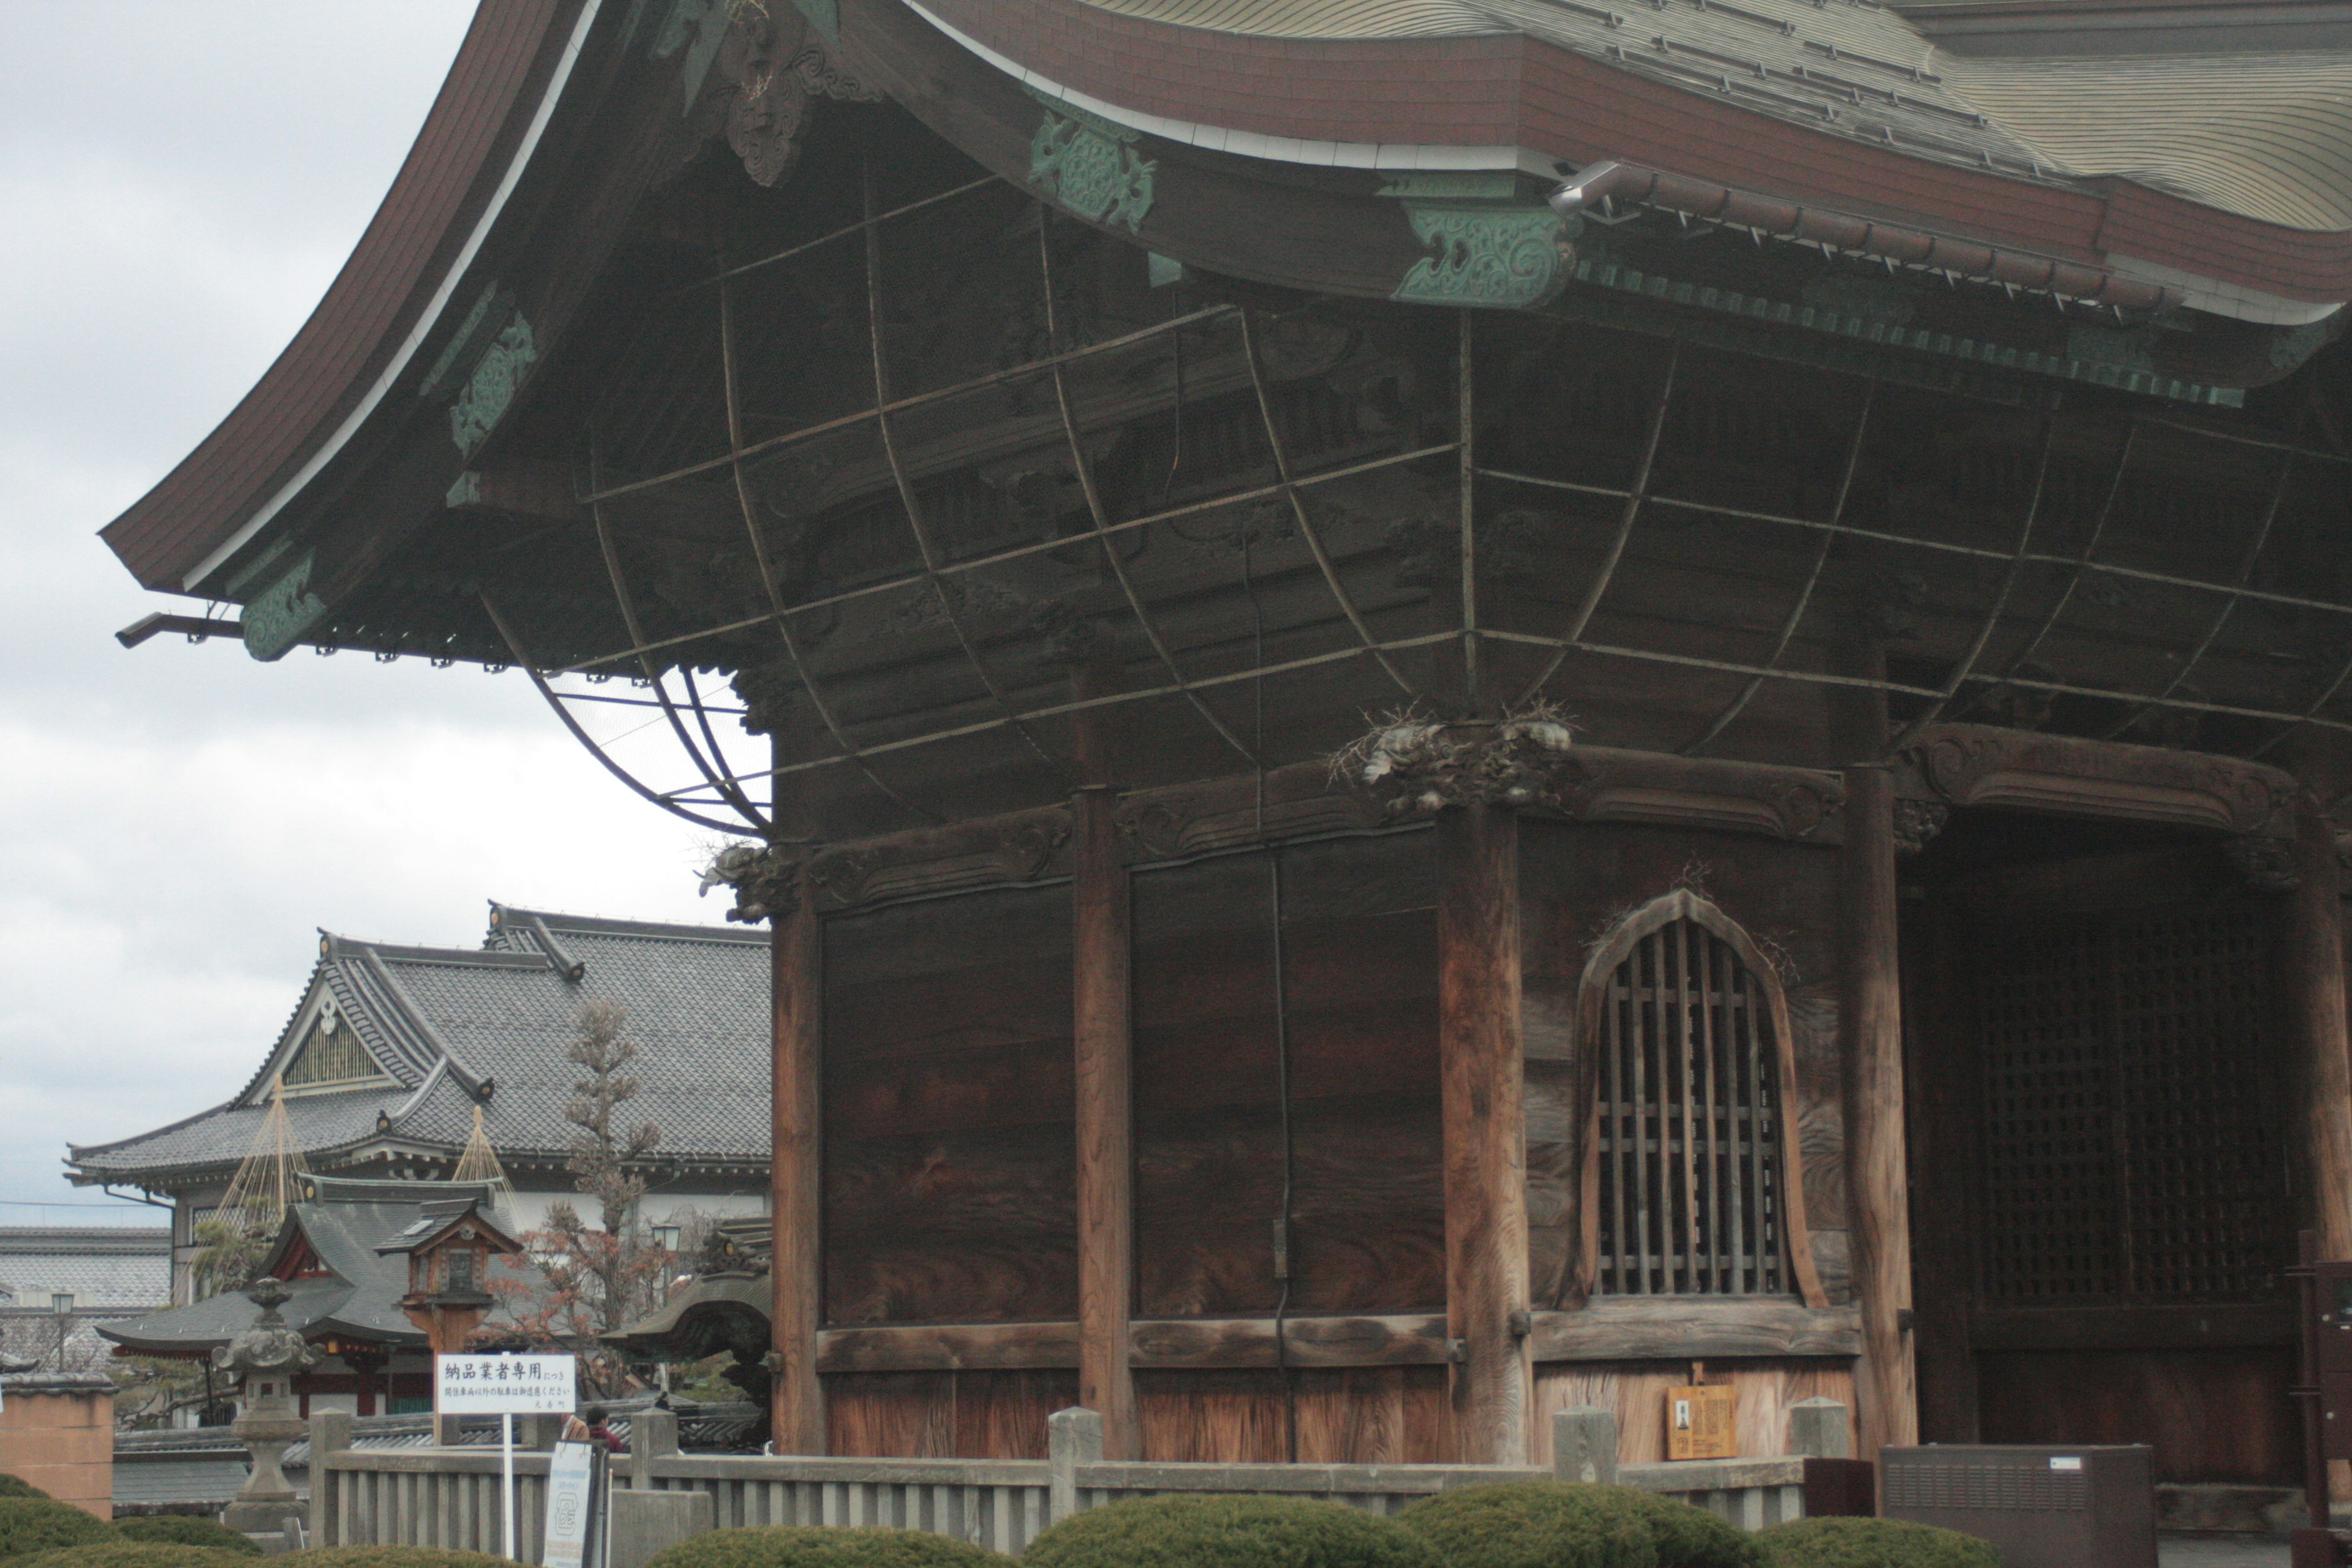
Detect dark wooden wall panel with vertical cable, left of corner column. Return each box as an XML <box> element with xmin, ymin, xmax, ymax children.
<box><xmin>1134</xmin><ymin>832</ymin><xmax>1444</xmax><ymax>1316</ymax></box>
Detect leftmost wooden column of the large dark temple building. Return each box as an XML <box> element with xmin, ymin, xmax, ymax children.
<box><xmin>769</xmin><ymin>870</ymin><xmax>826</xmax><ymax>1453</ymax></box>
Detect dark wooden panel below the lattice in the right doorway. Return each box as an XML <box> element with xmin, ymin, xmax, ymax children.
<box><xmin>1976</xmin><ymin>1349</ymin><xmax>2302</xmax><ymax>1486</ymax></box>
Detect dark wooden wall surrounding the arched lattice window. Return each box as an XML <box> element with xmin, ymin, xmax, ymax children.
<box><xmin>1520</xmin><ymin>818</ymin><xmax>1851</xmax><ymax>1307</ymax></box>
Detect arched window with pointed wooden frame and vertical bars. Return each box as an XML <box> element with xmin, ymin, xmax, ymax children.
<box><xmin>1580</xmin><ymin>889</ymin><xmax>1823</xmax><ymax>1307</ymax></box>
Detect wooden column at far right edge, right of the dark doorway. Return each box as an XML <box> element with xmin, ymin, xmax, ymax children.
<box><xmin>2279</xmin><ymin>806</ymin><xmax>2352</xmax><ymax>1260</ymax></box>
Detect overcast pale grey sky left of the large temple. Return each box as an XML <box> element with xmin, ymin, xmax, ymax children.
<box><xmin>0</xmin><ymin>0</ymin><xmax>722</xmax><ymax>1225</ymax></box>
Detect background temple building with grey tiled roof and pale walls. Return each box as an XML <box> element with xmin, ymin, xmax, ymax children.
<box><xmin>64</xmin><ymin>905</ymin><xmax>767</xmax><ymax>1306</ymax></box>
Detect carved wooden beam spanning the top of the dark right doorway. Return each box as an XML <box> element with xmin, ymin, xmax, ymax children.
<box><xmin>1896</xmin><ymin>724</ymin><xmax>2298</xmax><ymax>839</ymax></box>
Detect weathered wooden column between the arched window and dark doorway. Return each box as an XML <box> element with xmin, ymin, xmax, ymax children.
<box><xmin>1839</xmin><ymin>766</ymin><xmax>1919</xmax><ymax>1462</ymax></box>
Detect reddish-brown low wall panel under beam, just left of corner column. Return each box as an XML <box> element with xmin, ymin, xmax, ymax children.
<box><xmin>1136</xmin><ymin>1366</ymin><xmax>1453</xmax><ymax>1464</ymax></box>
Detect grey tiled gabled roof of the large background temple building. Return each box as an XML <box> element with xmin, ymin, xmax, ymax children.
<box><xmin>66</xmin><ymin>905</ymin><xmax>769</xmax><ymax>1189</ymax></box>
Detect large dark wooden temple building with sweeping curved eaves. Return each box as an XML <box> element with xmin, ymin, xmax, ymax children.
<box><xmin>106</xmin><ymin>0</ymin><xmax>2352</xmax><ymax>1486</ymax></box>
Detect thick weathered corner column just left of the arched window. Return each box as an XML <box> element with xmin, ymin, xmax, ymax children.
<box><xmin>1437</xmin><ymin>804</ymin><xmax>1531</xmax><ymax>1464</ymax></box>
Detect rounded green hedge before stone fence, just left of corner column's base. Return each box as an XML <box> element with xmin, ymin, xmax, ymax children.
<box><xmin>1025</xmin><ymin>1495</ymin><xmax>1439</xmax><ymax>1568</ymax></box>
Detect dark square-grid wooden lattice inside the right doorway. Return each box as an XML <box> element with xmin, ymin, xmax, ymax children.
<box><xmin>1980</xmin><ymin>910</ymin><xmax>2286</xmax><ymax>1302</ymax></box>
